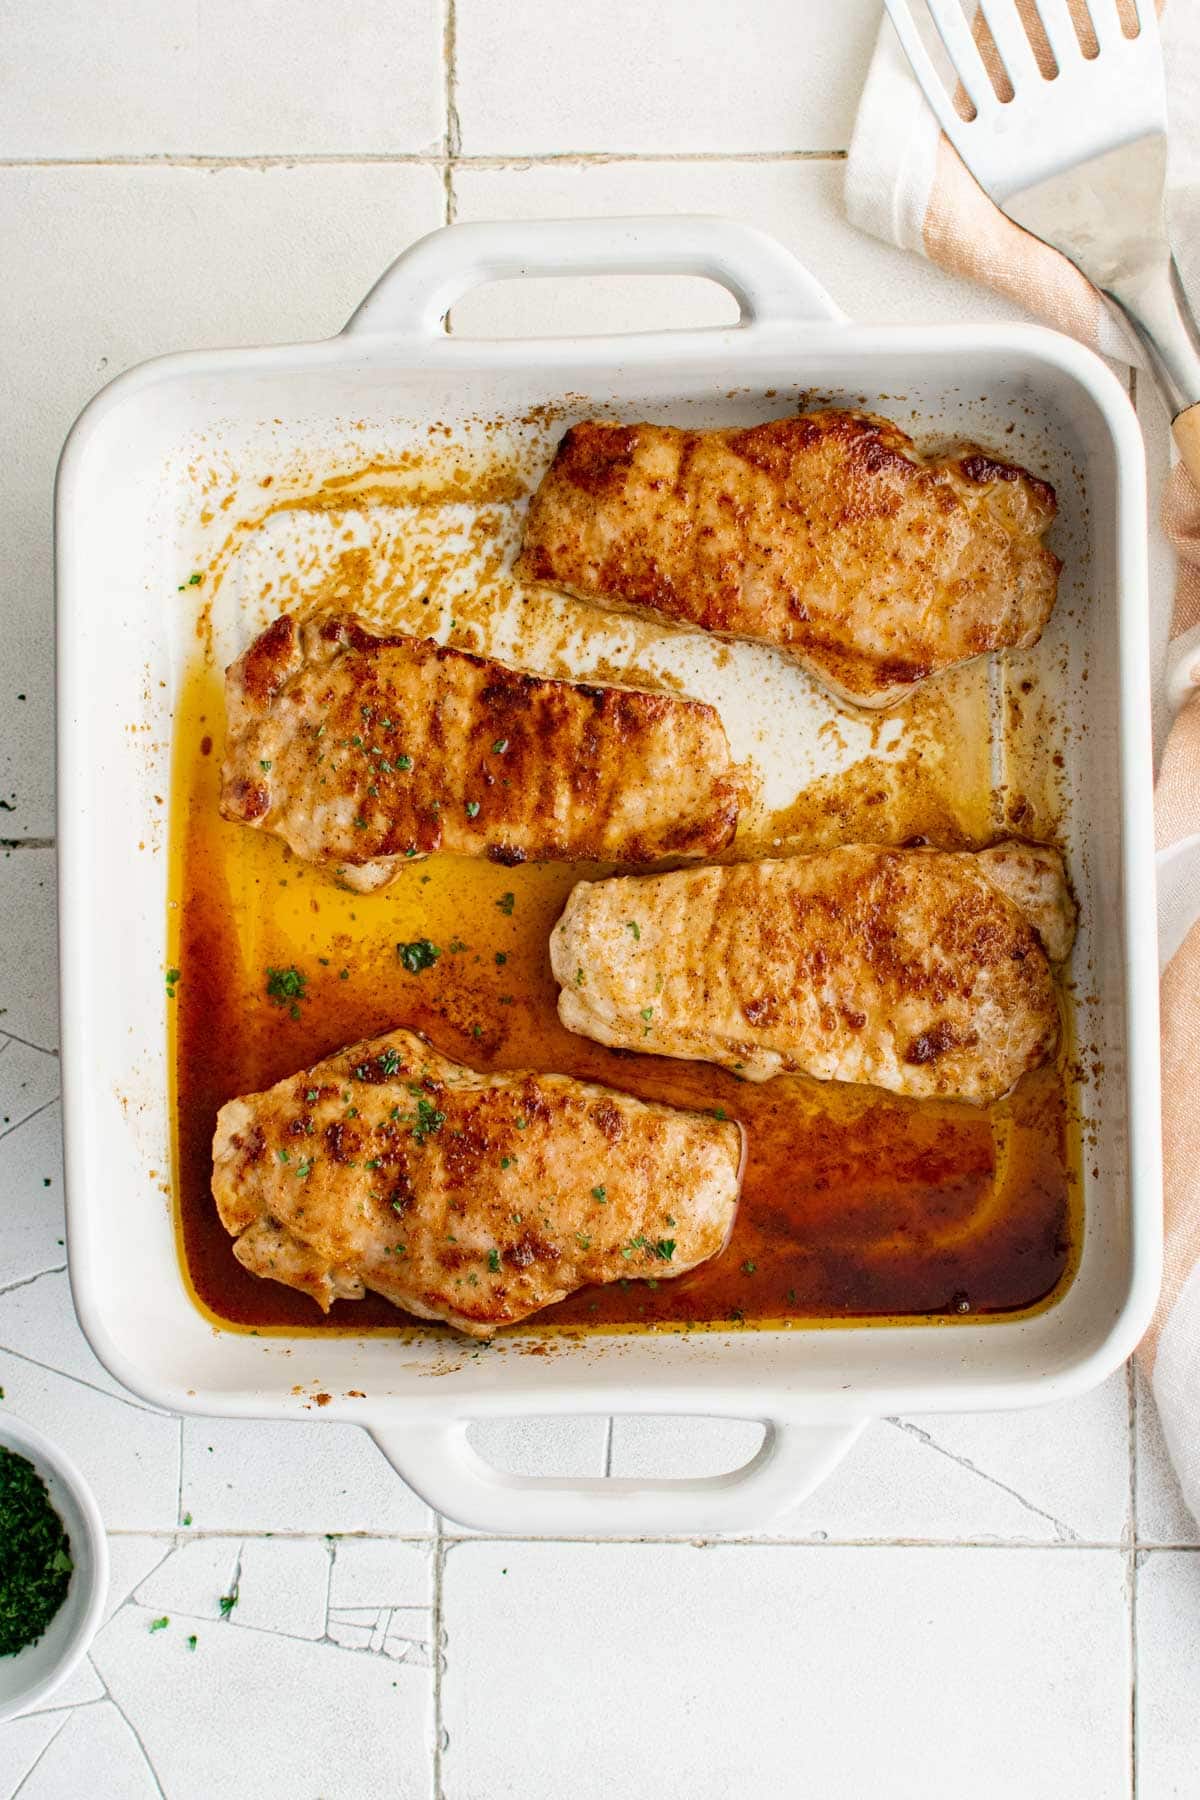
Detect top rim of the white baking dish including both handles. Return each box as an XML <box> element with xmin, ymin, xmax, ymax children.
<box><xmin>58</xmin><ymin>218</ymin><xmax>1162</xmax><ymax>1534</ymax></box>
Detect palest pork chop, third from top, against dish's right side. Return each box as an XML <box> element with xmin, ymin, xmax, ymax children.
<box><xmin>551</xmin><ymin>842</ymin><xmax>1074</xmax><ymax>1103</ymax></box>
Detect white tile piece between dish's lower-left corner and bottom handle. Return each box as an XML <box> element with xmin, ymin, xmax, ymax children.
<box><xmin>182</xmin><ymin>1418</ymin><xmax>434</xmax><ymax>1535</ymax></box>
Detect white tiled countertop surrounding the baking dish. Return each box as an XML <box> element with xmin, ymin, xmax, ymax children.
<box><xmin>0</xmin><ymin>0</ymin><xmax>1200</xmax><ymax>1800</ymax></box>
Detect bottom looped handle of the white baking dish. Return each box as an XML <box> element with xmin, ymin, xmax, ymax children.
<box><xmin>372</xmin><ymin>1418</ymin><xmax>865</xmax><ymax>1537</ymax></box>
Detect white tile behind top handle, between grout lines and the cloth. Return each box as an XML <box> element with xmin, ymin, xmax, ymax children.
<box><xmin>453</xmin><ymin>162</ymin><xmax>1043</xmax><ymax>337</ymax></box>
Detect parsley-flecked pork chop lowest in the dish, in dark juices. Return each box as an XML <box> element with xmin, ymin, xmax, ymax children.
<box><xmin>212</xmin><ymin>1030</ymin><xmax>741</xmax><ymax>1337</ymax></box>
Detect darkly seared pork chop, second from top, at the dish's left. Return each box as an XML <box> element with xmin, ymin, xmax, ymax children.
<box><xmin>221</xmin><ymin>614</ymin><xmax>739</xmax><ymax>893</ymax></box>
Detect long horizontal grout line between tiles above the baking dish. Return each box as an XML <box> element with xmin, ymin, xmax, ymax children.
<box><xmin>0</xmin><ymin>151</ymin><xmax>847</xmax><ymax>171</ymax></box>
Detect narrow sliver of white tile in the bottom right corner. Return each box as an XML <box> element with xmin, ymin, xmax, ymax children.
<box><xmin>1137</xmin><ymin>1550</ymin><xmax>1200</xmax><ymax>1800</ymax></box>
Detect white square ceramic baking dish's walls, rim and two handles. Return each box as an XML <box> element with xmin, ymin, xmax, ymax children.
<box><xmin>58</xmin><ymin>218</ymin><xmax>1160</xmax><ymax>1535</ymax></box>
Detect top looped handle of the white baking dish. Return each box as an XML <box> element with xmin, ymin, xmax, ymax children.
<box><xmin>345</xmin><ymin>212</ymin><xmax>846</xmax><ymax>342</ymax></box>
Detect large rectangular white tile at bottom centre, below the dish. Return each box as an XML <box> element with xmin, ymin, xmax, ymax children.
<box><xmin>443</xmin><ymin>1541</ymin><xmax>1130</xmax><ymax>1800</ymax></box>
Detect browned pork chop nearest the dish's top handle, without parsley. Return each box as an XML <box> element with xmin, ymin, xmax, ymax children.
<box><xmin>516</xmin><ymin>412</ymin><xmax>1060</xmax><ymax>707</ymax></box>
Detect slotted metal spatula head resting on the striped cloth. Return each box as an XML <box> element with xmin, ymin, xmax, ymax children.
<box><xmin>883</xmin><ymin>0</ymin><xmax>1200</xmax><ymax>457</ymax></box>
